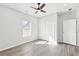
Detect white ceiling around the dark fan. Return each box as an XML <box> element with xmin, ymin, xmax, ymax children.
<box><xmin>3</xmin><ymin>3</ymin><xmax>79</xmax><ymax>17</ymax></box>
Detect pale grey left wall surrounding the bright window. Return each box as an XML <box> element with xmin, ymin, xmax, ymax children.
<box><xmin>0</xmin><ymin>5</ymin><xmax>37</xmax><ymax>51</ymax></box>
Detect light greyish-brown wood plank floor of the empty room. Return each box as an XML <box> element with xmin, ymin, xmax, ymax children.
<box><xmin>0</xmin><ymin>41</ymin><xmax>79</xmax><ymax>56</ymax></box>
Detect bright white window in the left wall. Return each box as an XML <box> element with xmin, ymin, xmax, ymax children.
<box><xmin>22</xmin><ymin>20</ymin><xmax>32</xmax><ymax>37</ymax></box>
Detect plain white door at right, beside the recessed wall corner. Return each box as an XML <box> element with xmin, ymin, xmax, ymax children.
<box><xmin>63</xmin><ymin>19</ymin><xmax>76</xmax><ymax>45</ymax></box>
